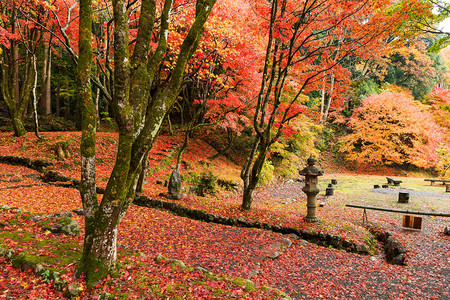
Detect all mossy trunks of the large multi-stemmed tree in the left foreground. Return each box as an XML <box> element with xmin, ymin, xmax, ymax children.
<box><xmin>78</xmin><ymin>0</ymin><xmax>216</xmax><ymax>285</ymax></box>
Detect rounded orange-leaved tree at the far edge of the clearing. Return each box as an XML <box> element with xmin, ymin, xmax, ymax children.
<box><xmin>340</xmin><ymin>92</ymin><xmax>443</xmax><ymax>168</ymax></box>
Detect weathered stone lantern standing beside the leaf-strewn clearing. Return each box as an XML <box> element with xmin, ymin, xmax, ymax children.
<box><xmin>299</xmin><ymin>157</ymin><xmax>323</xmax><ymax>223</ymax></box>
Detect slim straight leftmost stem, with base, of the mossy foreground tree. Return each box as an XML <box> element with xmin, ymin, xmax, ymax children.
<box><xmin>77</xmin><ymin>0</ymin><xmax>100</xmax><ymax>286</ymax></box>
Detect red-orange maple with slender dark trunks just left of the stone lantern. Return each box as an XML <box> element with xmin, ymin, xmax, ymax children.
<box><xmin>237</xmin><ymin>0</ymin><xmax>428</xmax><ymax>210</ymax></box>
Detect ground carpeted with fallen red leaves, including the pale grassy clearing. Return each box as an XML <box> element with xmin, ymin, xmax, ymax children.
<box><xmin>0</xmin><ymin>133</ymin><xmax>450</xmax><ymax>299</ymax></box>
